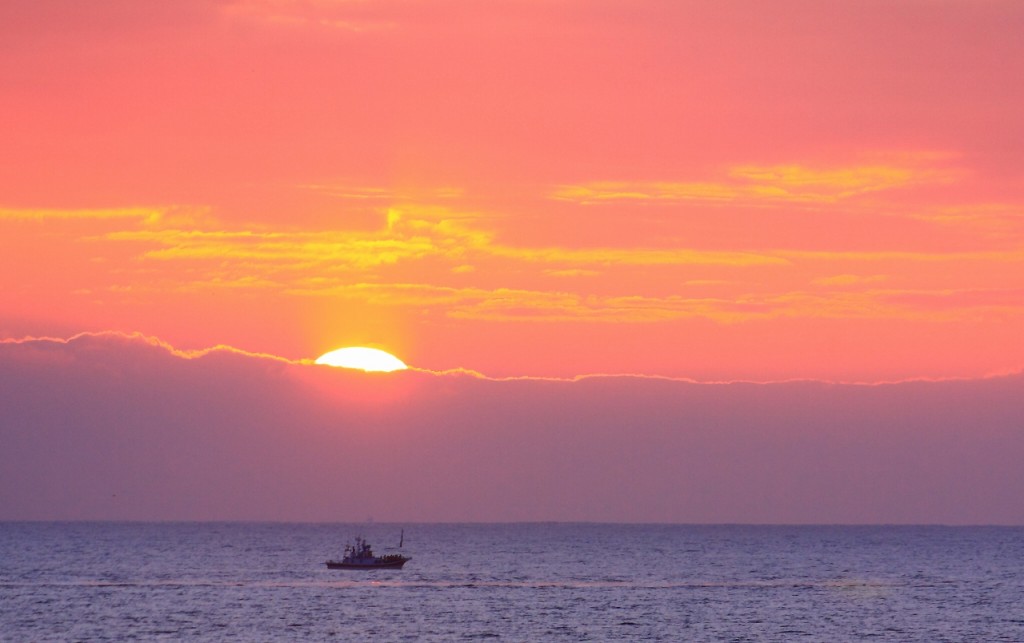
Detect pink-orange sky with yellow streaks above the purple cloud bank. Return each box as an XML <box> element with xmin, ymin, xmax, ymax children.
<box><xmin>0</xmin><ymin>0</ymin><xmax>1024</xmax><ymax>382</ymax></box>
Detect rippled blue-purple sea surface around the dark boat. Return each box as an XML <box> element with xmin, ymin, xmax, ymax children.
<box><xmin>0</xmin><ymin>522</ymin><xmax>1024</xmax><ymax>642</ymax></box>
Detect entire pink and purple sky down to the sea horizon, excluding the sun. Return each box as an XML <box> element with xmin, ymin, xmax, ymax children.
<box><xmin>0</xmin><ymin>0</ymin><xmax>1024</xmax><ymax>523</ymax></box>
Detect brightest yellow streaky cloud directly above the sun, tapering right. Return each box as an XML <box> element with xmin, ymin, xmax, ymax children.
<box><xmin>96</xmin><ymin>206</ymin><xmax>787</xmax><ymax>281</ymax></box>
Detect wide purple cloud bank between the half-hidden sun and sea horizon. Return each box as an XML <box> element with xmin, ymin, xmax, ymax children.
<box><xmin>0</xmin><ymin>334</ymin><xmax>1024</xmax><ymax>524</ymax></box>
